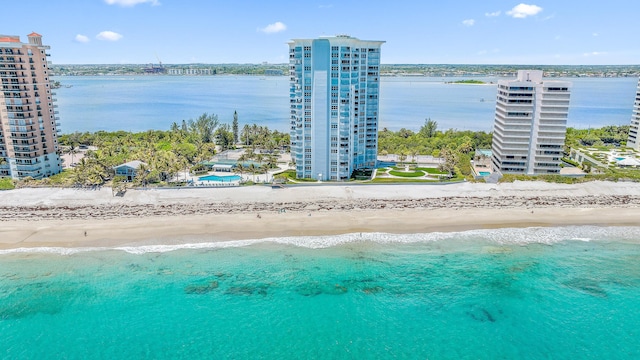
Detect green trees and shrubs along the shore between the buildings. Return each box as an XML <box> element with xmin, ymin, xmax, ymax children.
<box><xmin>0</xmin><ymin>113</ymin><xmax>640</xmax><ymax>190</ymax></box>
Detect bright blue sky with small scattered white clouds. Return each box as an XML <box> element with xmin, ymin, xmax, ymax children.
<box><xmin>5</xmin><ymin>0</ymin><xmax>640</xmax><ymax>65</ymax></box>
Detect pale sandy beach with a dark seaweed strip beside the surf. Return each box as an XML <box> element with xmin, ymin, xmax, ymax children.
<box><xmin>0</xmin><ymin>182</ymin><xmax>640</xmax><ymax>249</ymax></box>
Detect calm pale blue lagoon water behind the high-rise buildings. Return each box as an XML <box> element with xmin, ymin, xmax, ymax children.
<box><xmin>55</xmin><ymin>76</ymin><xmax>637</xmax><ymax>133</ymax></box>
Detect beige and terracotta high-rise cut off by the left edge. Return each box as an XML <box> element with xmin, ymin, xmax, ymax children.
<box><xmin>0</xmin><ymin>33</ymin><xmax>62</xmax><ymax>179</ymax></box>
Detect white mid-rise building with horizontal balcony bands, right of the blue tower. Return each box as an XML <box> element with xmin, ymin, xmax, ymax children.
<box><xmin>491</xmin><ymin>70</ymin><xmax>571</xmax><ymax>175</ymax></box>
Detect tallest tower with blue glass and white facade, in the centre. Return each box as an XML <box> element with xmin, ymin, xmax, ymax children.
<box><xmin>289</xmin><ymin>35</ymin><xmax>384</xmax><ymax>181</ymax></box>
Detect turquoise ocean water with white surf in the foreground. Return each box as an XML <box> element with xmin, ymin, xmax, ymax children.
<box><xmin>0</xmin><ymin>227</ymin><xmax>640</xmax><ymax>359</ymax></box>
